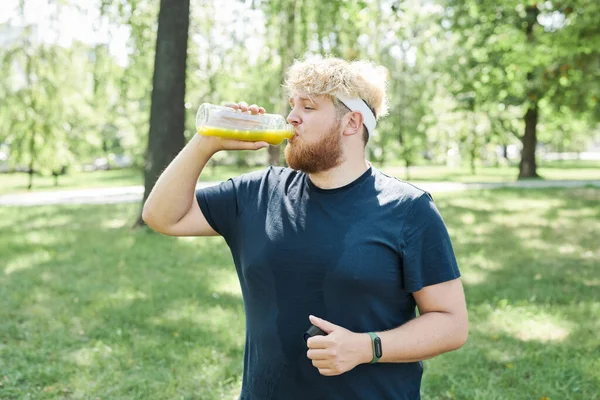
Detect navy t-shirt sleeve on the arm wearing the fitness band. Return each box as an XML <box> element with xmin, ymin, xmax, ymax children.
<box><xmin>402</xmin><ymin>193</ymin><xmax>460</xmax><ymax>293</ymax></box>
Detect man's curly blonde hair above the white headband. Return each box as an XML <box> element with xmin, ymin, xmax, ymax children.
<box><xmin>284</xmin><ymin>57</ymin><xmax>388</xmax><ymax>119</ymax></box>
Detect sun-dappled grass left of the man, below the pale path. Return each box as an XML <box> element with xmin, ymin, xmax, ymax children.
<box><xmin>0</xmin><ymin>205</ymin><xmax>244</xmax><ymax>398</ymax></box>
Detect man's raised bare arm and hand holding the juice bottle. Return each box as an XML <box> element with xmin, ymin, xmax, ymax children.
<box><xmin>142</xmin><ymin>102</ymin><xmax>268</xmax><ymax>236</ymax></box>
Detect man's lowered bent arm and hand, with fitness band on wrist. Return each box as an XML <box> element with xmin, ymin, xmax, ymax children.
<box><xmin>307</xmin><ymin>278</ymin><xmax>469</xmax><ymax>376</ymax></box>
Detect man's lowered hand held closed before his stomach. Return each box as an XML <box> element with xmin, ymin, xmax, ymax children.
<box><xmin>306</xmin><ymin>315</ymin><xmax>373</xmax><ymax>376</ymax></box>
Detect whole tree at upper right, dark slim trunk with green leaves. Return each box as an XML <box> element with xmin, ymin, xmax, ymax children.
<box><xmin>441</xmin><ymin>0</ymin><xmax>600</xmax><ymax>179</ymax></box>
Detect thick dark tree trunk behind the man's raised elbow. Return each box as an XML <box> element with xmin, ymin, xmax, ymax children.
<box><xmin>135</xmin><ymin>0</ymin><xmax>190</xmax><ymax>226</ymax></box>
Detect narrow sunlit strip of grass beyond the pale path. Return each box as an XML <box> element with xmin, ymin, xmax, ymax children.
<box><xmin>0</xmin><ymin>161</ymin><xmax>600</xmax><ymax>195</ymax></box>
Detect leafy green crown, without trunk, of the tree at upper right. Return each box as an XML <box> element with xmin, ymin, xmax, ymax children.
<box><xmin>440</xmin><ymin>0</ymin><xmax>600</xmax><ymax>156</ymax></box>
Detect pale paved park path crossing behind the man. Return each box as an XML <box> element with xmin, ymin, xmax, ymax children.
<box><xmin>0</xmin><ymin>179</ymin><xmax>600</xmax><ymax>206</ymax></box>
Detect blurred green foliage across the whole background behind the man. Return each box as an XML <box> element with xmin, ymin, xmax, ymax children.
<box><xmin>0</xmin><ymin>0</ymin><xmax>600</xmax><ymax>188</ymax></box>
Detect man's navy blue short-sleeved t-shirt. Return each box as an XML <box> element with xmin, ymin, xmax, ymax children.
<box><xmin>196</xmin><ymin>166</ymin><xmax>460</xmax><ymax>400</ymax></box>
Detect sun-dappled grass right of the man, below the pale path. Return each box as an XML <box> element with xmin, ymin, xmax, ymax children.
<box><xmin>423</xmin><ymin>188</ymin><xmax>600</xmax><ymax>400</ymax></box>
